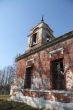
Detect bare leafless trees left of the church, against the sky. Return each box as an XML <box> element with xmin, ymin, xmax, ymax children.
<box><xmin>0</xmin><ymin>65</ymin><xmax>16</xmax><ymax>85</ymax></box>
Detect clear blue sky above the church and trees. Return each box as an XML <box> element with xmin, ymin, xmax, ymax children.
<box><xmin>0</xmin><ymin>0</ymin><xmax>73</xmax><ymax>69</ymax></box>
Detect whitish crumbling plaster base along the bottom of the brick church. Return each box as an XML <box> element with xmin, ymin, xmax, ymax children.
<box><xmin>11</xmin><ymin>92</ymin><xmax>73</xmax><ymax>110</ymax></box>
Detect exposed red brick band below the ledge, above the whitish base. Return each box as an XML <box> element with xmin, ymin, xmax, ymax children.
<box><xmin>23</xmin><ymin>90</ymin><xmax>73</xmax><ymax>103</ymax></box>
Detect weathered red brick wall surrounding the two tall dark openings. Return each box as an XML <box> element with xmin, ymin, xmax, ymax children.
<box><xmin>17</xmin><ymin>38</ymin><xmax>73</xmax><ymax>90</ymax></box>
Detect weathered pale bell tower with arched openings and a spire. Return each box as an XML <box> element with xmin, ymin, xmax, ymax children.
<box><xmin>26</xmin><ymin>17</ymin><xmax>54</xmax><ymax>51</ymax></box>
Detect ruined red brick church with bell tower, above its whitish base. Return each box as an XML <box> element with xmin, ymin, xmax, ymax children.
<box><xmin>16</xmin><ymin>18</ymin><xmax>73</xmax><ymax>103</ymax></box>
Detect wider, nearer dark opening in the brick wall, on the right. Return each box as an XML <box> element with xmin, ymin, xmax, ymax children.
<box><xmin>52</xmin><ymin>59</ymin><xmax>65</xmax><ymax>90</ymax></box>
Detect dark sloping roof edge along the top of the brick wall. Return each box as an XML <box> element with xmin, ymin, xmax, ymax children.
<box><xmin>15</xmin><ymin>31</ymin><xmax>73</xmax><ymax>62</ymax></box>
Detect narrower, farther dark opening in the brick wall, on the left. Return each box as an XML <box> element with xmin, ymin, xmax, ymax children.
<box><xmin>24</xmin><ymin>67</ymin><xmax>32</xmax><ymax>89</ymax></box>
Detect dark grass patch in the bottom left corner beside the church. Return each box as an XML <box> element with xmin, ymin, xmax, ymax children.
<box><xmin>0</xmin><ymin>95</ymin><xmax>38</xmax><ymax>110</ymax></box>
